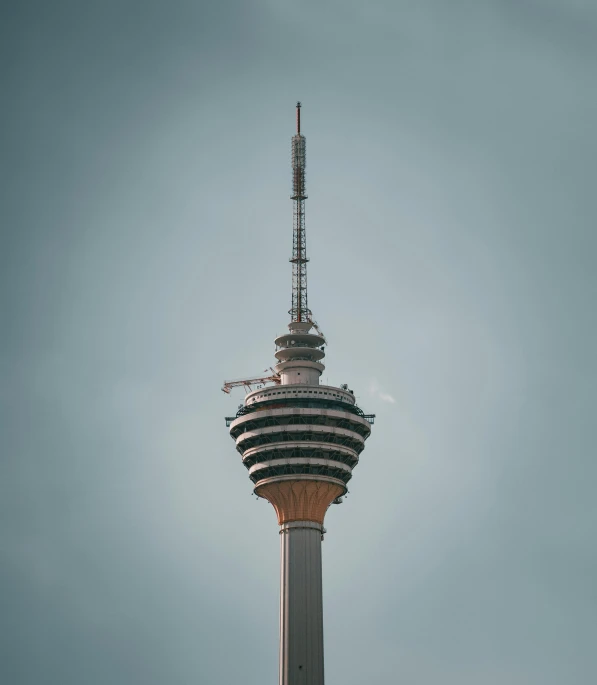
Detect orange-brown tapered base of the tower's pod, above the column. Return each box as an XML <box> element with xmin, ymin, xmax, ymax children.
<box><xmin>255</xmin><ymin>479</ymin><xmax>346</xmax><ymax>525</ymax></box>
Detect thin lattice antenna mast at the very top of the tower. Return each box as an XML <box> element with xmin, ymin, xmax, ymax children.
<box><xmin>288</xmin><ymin>102</ymin><xmax>311</xmax><ymax>322</ymax></box>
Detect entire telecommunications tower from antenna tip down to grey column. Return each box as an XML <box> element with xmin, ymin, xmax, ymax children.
<box><xmin>222</xmin><ymin>102</ymin><xmax>375</xmax><ymax>685</ymax></box>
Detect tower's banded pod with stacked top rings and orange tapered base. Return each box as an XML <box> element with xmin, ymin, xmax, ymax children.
<box><xmin>226</xmin><ymin>322</ymin><xmax>375</xmax><ymax>524</ymax></box>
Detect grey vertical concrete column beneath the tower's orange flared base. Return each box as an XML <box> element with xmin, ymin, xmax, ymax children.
<box><xmin>280</xmin><ymin>521</ymin><xmax>324</xmax><ymax>685</ymax></box>
